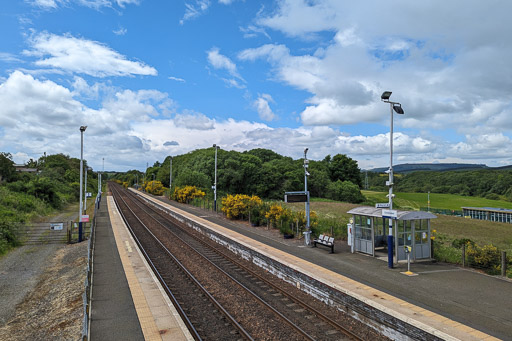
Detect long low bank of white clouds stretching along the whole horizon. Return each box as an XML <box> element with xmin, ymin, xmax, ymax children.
<box><xmin>0</xmin><ymin>71</ymin><xmax>512</xmax><ymax>170</ymax></box>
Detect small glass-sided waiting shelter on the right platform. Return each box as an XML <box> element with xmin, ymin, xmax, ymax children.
<box><xmin>347</xmin><ymin>206</ymin><xmax>437</xmax><ymax>263</ymax></box>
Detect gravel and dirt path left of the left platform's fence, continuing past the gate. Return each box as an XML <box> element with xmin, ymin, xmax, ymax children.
<box><xmin>0</xmin><ymin>203</ymin><xmax>87</xmax><ymax>340</ymax></box>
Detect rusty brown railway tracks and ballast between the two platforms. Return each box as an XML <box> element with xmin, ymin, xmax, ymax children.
<box><xmin>110</xmin><ymin>184</ymin><xmax>378</xmax><ymax>340</ymax></box>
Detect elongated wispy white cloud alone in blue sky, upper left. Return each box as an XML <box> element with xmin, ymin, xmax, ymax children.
<box><xmin>24</xmin><ymin>32</ymin><xmax>157</xmax><ymax>77</ymax></box>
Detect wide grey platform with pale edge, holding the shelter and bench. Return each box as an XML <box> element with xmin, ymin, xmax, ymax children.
<box><xmin>131</xmin><ymin>192</ymin><xmax>512</xmax><ymax>340</ymax></box>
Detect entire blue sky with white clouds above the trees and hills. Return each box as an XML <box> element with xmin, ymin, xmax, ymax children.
<box><xmin>0</xmin><ymin>0</ymin><xmax>512</xmax><ymax>171</ymax></box>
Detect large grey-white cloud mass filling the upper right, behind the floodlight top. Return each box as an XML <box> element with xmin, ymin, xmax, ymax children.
<box><xmin>238</xmin><ymin>0</ymin><xmax>512</xmax><ymax>134</ymax></box>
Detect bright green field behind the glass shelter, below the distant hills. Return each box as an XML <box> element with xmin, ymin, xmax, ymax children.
<box><xmin>362</xmin><ymin>191</ymin><xmax>512</xmax><ymax>211</ymax></box>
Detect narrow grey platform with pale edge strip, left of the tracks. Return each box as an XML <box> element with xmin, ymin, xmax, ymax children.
<box><xmin>89</xmin><ymin>195</ymin><xmax>193</xmax><ymax>341</ymax></box>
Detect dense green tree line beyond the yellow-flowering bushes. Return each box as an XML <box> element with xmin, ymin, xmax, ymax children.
<box><xmin>116</xmin><ymin>148</ymin><xmax>365</xmax><ymax>203</ymax></box>
